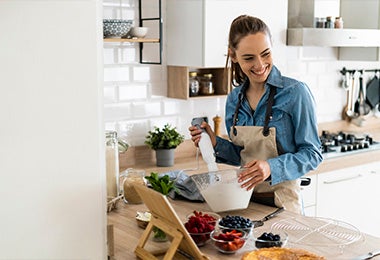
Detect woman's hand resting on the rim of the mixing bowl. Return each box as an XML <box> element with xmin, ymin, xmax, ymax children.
<box><xmin>238</xmin><ymin>160</ymin><xmax>270</xmax><ymax>190</ymax></box>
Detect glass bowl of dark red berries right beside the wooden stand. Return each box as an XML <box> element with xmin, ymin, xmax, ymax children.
<box><xmin>184</xmin><ymin>210</ymin><xmax>220</xmax><ymax>247</ymax></box>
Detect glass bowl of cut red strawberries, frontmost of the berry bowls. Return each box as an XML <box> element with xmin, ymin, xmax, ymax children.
<box><xmin>210</xmin><ymin>229</ymin><xmax>249</xmax><ymax>254</ymax></box>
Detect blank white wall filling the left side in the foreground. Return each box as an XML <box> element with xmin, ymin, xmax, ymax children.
<box><xmin>0</xmin><ymin>0</ymin><xmax>106</xmax><ymax>259</ymax></box>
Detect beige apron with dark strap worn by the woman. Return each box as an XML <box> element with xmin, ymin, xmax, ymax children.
<box><xmin>230</xmin><ymin>87</ymin><xmax>303</xmax><ymax>214</ymax></box>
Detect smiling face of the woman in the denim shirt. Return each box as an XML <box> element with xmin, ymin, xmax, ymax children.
<box><xmin>231</xmin><ymin>32</ymin><xmax>273</xmax><ymax>84</ymax></box>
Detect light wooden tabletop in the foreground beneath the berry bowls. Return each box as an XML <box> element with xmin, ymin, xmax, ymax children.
<box><xmin>108</xmin><ymin>196</ymin><xmax>380</xmax><ymax>260</ymax></box>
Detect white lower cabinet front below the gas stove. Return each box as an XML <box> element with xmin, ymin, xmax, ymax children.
<box><xmin>316</xmin><ymin>162</ymin><xmax>380</xmax><ymax>237</ymax></box>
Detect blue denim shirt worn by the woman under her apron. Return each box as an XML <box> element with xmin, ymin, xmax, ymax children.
<box><xmin>214</xmin><ymin>66</ymin><xmax>323</xmax><ymax>185</ymax></box>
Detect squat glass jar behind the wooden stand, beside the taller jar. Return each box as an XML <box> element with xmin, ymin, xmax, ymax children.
<box><xmin>120</xmin><ymin>168</ymin><xmax>146</xmax><ymax>204</ymax></box>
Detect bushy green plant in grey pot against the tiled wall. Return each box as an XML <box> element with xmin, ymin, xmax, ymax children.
<box><xmin>145</xmin><ymin>124</ymin><xmax>185</xmax><ymax>167</ymax></box>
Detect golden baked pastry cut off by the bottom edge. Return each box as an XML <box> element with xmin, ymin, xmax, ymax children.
<box><xmin>242</xmin><ymin>247</ymin><xmax>325</xmax><ymax>260</ymax></box>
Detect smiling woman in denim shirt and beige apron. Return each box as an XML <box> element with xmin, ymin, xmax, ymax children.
<box><xmin>189</xmin><ymin>15</ymin><xmax>322</xmax><ymax>213</ymax></box>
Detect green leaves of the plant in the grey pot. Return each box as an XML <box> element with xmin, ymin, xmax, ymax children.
<box><xmin>145</xmin><ymin>124</ymin><xmax>185</xmax><ymax>150</ymax></box>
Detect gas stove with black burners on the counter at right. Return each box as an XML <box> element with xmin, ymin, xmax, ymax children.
<box><xmin>319</xmin><ymin>130</ymin><xmax>380</xmax><ymax>159</ymax></box>
